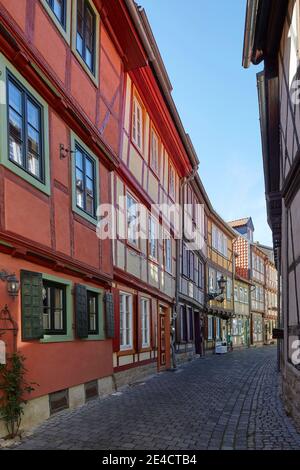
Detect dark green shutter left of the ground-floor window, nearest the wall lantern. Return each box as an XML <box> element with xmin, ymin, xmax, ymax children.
<box><xmin>21</xmin><ymin>271</ymin><xmax>44</xmax><ymax>341</ymax></box>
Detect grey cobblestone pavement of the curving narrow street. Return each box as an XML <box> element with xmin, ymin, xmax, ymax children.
<box><xmin>10</xmin><ymin>347</ymin><xmax>300</xmax><ymax>450</ymax></box>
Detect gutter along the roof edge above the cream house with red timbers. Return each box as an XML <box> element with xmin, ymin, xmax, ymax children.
<box><xmin>125</xmin><ymin>0</ymin><xmax>199</xmax><ymax>168</ymax></box>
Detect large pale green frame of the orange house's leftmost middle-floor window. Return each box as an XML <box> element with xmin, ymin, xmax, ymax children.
<box><xmin>0</xmin><ymin>53</ymin><xmax>51</xmax><ymax>196</ymax></box>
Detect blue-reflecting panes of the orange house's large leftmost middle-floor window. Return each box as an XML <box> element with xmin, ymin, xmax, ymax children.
<box><xmin>7</xmin><ymin>74</ymin><xmax>44</xmax><ymax>181</ymax></box>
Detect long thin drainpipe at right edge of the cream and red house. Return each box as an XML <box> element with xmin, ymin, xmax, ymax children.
<box><xmin>171</xmin><ymin>166</ymin><xmax>198</xmax><ymax>370</ymax></box>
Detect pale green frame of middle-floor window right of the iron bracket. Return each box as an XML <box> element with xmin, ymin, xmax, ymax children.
<box><xmin>71</xmin><ymin>131</ymin><xmax>100</xmax><ymax>225</ymax></box>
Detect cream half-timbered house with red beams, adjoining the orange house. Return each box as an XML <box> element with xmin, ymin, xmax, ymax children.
<box><xmin>111</xmin><ymin>1</ymin><xmax>198</xmax><ymax>386</ymax></box>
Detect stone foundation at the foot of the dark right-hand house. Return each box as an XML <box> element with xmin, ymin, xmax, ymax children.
<box><xmin>282</xmin><ymin>364</ymin><xmax>300</xmax><ymax>432</ymax></box>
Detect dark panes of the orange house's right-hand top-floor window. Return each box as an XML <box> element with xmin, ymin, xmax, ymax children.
<box><xmin>76</xmin><ymin>0</ymin><xmax>96</xmax><ymax>73</ymax></box>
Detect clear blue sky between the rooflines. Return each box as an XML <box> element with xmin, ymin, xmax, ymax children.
<box><xmin>139</xmin><ymin>0</ymin><xmax>272</xmax><ymax>244</ymax></box>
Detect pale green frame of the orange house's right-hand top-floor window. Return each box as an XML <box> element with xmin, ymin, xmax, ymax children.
<box><xmin>72</xmin><ymin>0</ymin><xmax>100</xmax><ymax>87</ymax></box>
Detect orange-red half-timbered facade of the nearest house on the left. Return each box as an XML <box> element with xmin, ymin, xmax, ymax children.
<box><xmin>0</xmin><ymin>0</ymin><xmax>123</xmax><ymax>414</ymax></box>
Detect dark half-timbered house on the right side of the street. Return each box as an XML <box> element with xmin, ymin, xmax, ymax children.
<box><xmin>243</xmin><ymin>0</ymin><xmax>300</xmax><ymax>426</ymax></box>
